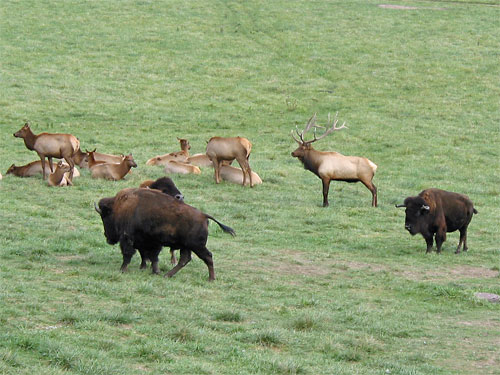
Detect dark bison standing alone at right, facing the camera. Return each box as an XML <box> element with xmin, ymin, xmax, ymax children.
<box><xmin>396</xmin><ymin>189</ymin><xmax>477</xmax><ymax>254</ymax></box>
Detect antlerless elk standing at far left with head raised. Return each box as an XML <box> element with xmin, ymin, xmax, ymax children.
<box><xmin>14</xmin><ymin>123</ymin><xmax>80</xmax><ymax>179</ymax></box>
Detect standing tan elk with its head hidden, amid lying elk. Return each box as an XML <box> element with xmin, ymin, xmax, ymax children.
<box><xmin>206</xmin><ymin>137</ymin><xmax>253</xmax><ymax>187</ymax></box>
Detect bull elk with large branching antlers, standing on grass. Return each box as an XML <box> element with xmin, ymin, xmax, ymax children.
<box><xmin>292</xmin><ymin>114</ymin><xmax>377</xmax><ymax>207</ymax></box>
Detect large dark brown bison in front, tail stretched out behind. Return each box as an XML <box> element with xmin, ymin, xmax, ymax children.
<box><xmin>96</xmin><ymin>188</ymin><xmax>235</xmax><ymax>281</ymax></box>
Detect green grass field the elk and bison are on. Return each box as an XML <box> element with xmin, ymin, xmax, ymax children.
<box><xmin>0</xmin><ymin>0</ymin><xmax>500</xmax><ymax>375</ymax></box>
